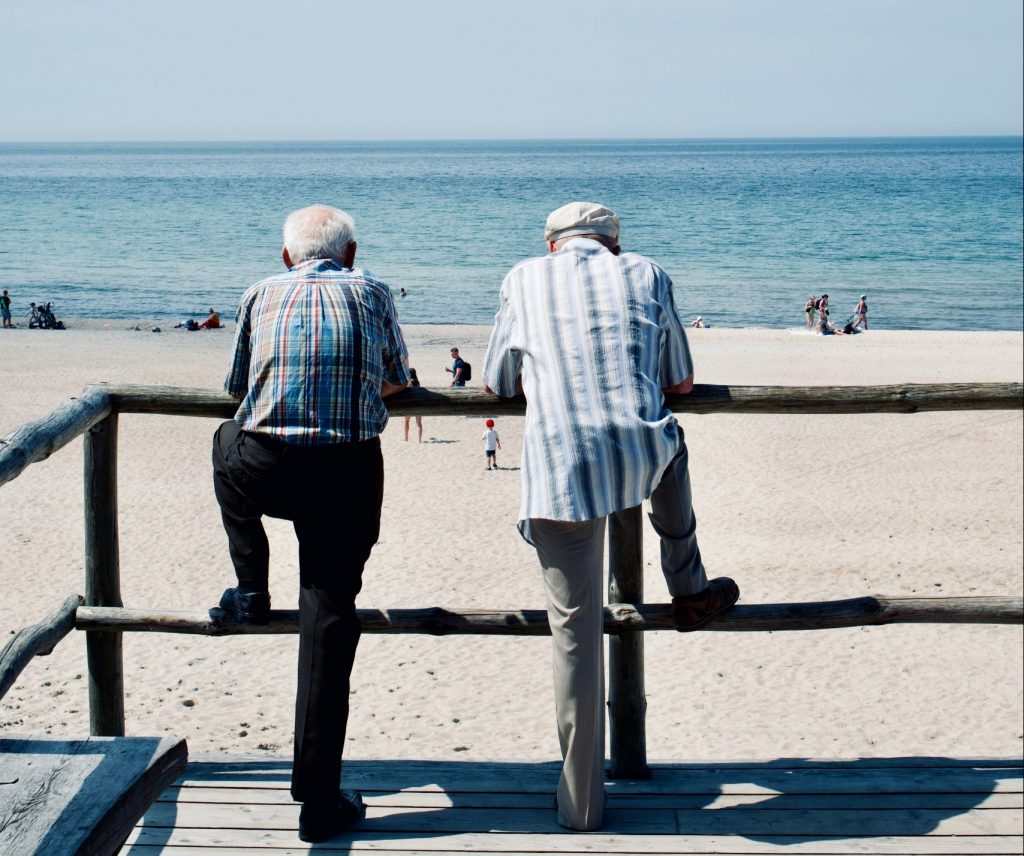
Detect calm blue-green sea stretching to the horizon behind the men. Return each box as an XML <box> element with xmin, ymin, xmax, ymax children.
<box><xmin>0</xmin><ymin>136</ymin><xmax>1024</xmax><ymax>331</ymax></box>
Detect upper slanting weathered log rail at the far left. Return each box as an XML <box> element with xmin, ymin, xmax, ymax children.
<box><xmin>0</xmin><ymin>386</ymin><xmax>112</xmax><ymax>484</ymax></box>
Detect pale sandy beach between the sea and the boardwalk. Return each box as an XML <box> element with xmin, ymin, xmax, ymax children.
<box><xmin>0</xmin><ymin>319</ymin><xmax>1024</xmax><ymax>761</ymax></box>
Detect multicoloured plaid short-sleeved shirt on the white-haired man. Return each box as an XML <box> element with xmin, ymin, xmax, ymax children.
<box><xmin>224</xmin><ymin>259</ymin><xmax>410</xmax><ymax>445</ymax></box>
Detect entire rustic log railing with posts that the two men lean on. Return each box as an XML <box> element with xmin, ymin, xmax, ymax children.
<box><xmin>0</xmin><ymin>383</ymin><xmax>1024</xmax><ymax>778</ymax></box>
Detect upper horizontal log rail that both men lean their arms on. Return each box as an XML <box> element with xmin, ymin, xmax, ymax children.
<box><xmin>90</xmin><ymin>383</ymin><xmax>1024</xmax><ymax>419</ymax></box>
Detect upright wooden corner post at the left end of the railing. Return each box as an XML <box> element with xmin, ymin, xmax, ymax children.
<box><xmin>84</xmin><ymin>412</ymin><xmax>125</xmax><ymax>737</ymax></box>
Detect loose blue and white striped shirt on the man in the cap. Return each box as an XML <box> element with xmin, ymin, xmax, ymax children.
<box><xmin>483</xmin><ymin>239</ymin><xmax>693</xmax><ymax>540</ymax></box>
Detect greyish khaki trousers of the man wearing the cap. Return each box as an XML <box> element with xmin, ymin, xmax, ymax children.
<box><xmin>529</xmin><ymin>431</ymin><xmax>708</xmax><ymax>829</ymax></box>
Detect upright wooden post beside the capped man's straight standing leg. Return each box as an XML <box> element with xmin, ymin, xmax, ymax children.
<box><xmin>608</xmin><ymin>506</ymin><xmax>650</xmax><ymax>779</ymax></box>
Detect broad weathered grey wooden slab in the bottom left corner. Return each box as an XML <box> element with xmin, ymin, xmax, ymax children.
<box><xmin>0</xmin><ymin>737</ymin><xmax>187</xmax><ymax>856</ymax></box>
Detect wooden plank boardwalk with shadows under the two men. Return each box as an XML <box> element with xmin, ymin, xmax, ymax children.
<box><xmin>122</xmin><ymin>756</ymin><xmax>1024</xmax><ymax>856</ymax></box>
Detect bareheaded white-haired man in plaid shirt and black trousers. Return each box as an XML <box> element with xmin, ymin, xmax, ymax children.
<box><xmin>210</xmin><ymin>205</ymin><xmax>410</xmax><ymax>842</ymax></box>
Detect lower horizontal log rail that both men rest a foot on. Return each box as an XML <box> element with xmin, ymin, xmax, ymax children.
<box><xmin>76</xmin><ymin>595</ymin><xmax>1024</xmax><ymax>636</ymax></box>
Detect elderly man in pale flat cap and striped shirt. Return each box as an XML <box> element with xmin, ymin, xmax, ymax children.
<box><xmin>483</xmin><ymin>202</ymin><xmax>739</xmax><ymax>829</ymax></box>
